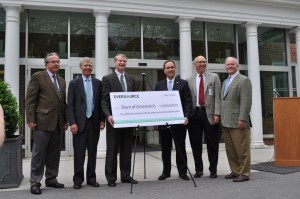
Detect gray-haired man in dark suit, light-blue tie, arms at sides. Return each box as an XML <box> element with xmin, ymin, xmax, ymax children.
<box><xmin>68</xmin><ymin>57</ymin><xmax>104</xmax><ymax>189</ymax></box>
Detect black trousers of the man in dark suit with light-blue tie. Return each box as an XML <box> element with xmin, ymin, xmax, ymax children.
<box><xmin>73</xmin><ymin>116</ymin><xmax>100</xmax><ymax>184</ymax></box>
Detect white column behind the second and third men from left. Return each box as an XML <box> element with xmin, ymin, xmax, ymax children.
<box><xmin>94</xmin><ymin>10</ymin><xmax>110</xmax><ymax>80</ymax></box>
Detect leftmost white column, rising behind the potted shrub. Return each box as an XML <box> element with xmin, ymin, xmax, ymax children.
<box><xmin>3</xmin><ymin>4</ymin><xmax>23</xmax><ymax>102</ymax></box>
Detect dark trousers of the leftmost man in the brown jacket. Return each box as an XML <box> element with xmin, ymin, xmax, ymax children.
<box><xmin>30</xmin><ymin>128</ymin><xmax>61</xmax><ymax>185</ymax></box>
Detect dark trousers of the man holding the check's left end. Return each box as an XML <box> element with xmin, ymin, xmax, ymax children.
<box><xmin>105</xmin><ymin>122</ymin><xmax>133</xmax><ymax>182</ymax></box>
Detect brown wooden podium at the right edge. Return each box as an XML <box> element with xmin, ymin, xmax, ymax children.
<box><xmin>273</xmin><ymin>97</ymin><xmax>300</xmax><ymax>166</ymax></box>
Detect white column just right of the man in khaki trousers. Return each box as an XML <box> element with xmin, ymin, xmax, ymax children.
<box><xmin>245</xmin><ymin>23</ymin><xmax>265</xmax><ymax>147</ymax></box>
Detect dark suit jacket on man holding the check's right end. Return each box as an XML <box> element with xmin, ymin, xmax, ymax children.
<box><xmin>155</xmin><ymin>77</ymin><xmax>193</xmax><ymax>117</ymax></box>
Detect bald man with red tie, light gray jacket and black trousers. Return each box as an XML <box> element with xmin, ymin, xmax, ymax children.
<box><xmin>188</xmin><ymin>55</ymin><xmax>221</xmax><ymax>178</ymax></box>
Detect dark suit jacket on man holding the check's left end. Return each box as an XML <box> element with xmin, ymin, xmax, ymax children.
<box><xmin>101</xmin><ymin>71</ymin><xmax>135</xmax><ymax>118</ymax></box>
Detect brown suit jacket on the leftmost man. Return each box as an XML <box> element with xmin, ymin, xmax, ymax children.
<box><xmin>25</xmin><ymin>70</ymin><xmax>68</xmax><ymax>131</ymax></box>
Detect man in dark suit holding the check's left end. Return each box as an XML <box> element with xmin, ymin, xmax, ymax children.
<box><xmin>101</xmin><ymin>54</ymin><xmax>138</xmax><ymax>187</ymax></box>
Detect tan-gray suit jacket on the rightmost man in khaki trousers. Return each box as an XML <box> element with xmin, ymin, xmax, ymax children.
<box><xmin>221</xmin><ymin>74</ymin><xmax>252</xmax><ymax>128</ymax></box>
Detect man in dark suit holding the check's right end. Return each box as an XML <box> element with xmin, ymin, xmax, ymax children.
<box><xmin>155</xmin><ymin>60</ymin><xmax>192</xmax><ymax>180</ymax></box>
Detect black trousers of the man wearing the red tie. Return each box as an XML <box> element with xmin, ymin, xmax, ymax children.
<box><xmin>188</xmin><ymin>108</ymin><xmax>220</xmax><ymax>173</ymax></box>
